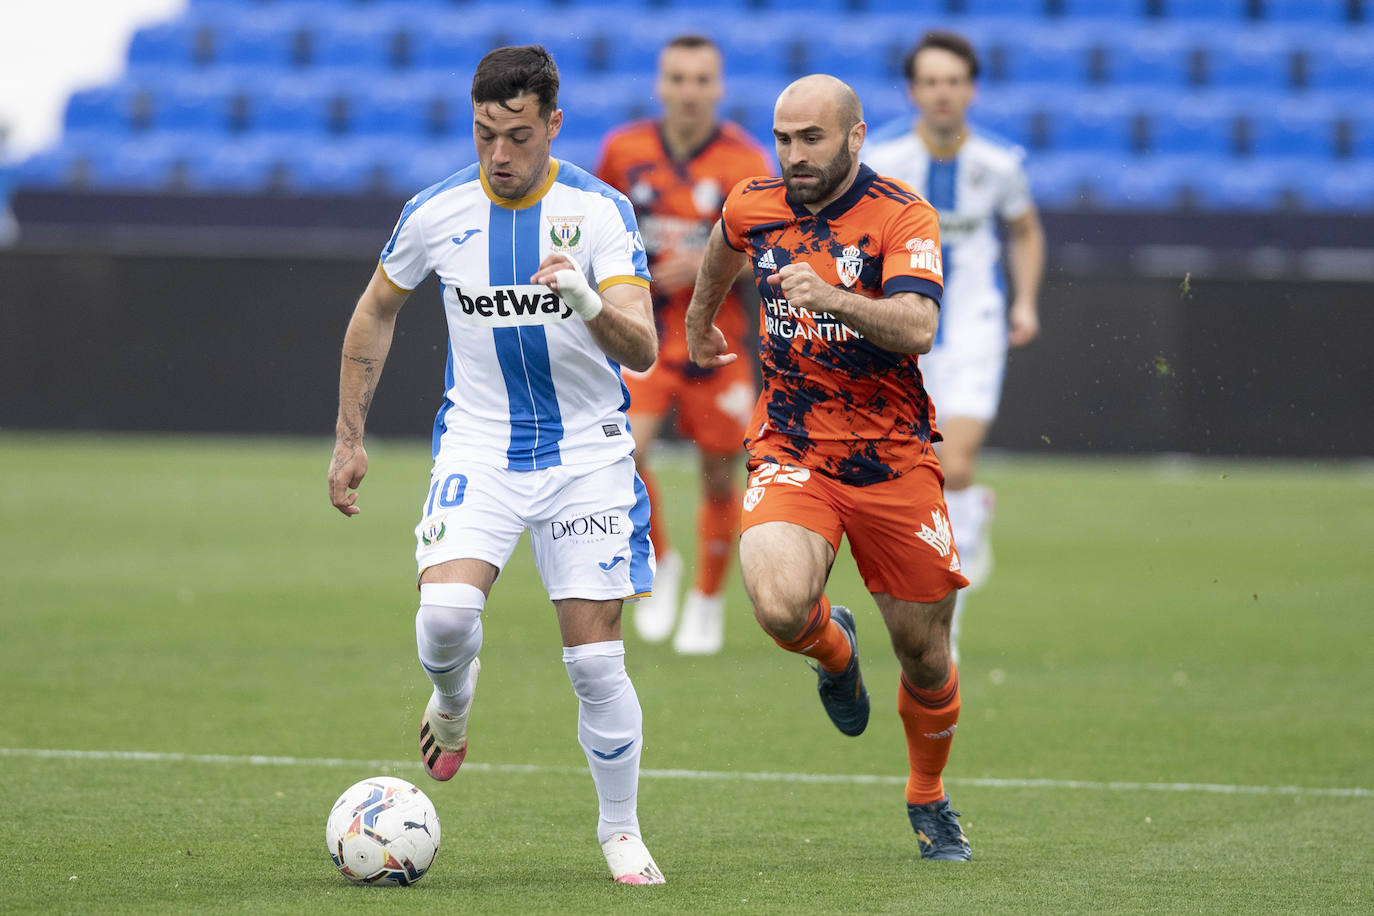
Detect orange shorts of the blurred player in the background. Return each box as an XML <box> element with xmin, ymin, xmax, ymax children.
<box><xmin>624</xmin><ymin>360</ymin><xmax>758</xmax><ymax>455</ymax></box>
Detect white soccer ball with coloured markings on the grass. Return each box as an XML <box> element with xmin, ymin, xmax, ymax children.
<box><xmin>324</xmin><ymin>776</ymin><xmax>438</xmax><ymax>884</ymax></box>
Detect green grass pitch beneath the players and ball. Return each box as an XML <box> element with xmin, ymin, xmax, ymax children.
<box><xmin>0</xmin><ymin>433</ymin><xmax>1374</xmax><ymax>913</ymax></box>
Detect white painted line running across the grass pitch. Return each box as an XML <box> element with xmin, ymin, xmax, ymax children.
<box><xmin>0</xmin><ymin>747</ymin><xmax>1374</xmax><ymax>798</ymax></box>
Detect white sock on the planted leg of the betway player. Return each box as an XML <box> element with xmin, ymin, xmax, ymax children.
<box><xmin>563</xmin><ymin>640</ymin><xmax>644</xmax><ymax>843</ymax></box>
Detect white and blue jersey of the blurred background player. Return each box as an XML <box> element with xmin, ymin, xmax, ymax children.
<box><xmin>863</xmin><ymin>121</ymin><xmax>1032</xmax><ymax>324</ymax></box>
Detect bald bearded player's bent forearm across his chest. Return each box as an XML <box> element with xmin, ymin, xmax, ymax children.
<box><xmin>768</xmin><ymin>261</ymin><xmax>940</xmax><ymax>353</ymax></box>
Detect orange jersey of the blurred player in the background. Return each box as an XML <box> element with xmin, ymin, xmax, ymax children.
<box><xmin>596</xmin><ymin>119</ymin><xmax>771</xmax><ymax>374</ymax></box>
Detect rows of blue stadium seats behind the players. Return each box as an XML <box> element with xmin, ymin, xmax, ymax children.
<box><xmin>11</xmin><ymin>0</ymin><xmax>1374</xmax><ymax>211</ymax></box>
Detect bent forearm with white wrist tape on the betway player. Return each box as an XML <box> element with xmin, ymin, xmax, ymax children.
<box><xmin>529</xmin><ymin>254</ymin><xmax>658</xmax><ymax>372</ymax></box>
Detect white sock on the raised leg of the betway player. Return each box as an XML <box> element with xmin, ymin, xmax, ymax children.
<box><xmin>415</xmin><ymin>582</ymin><xmax>486</xmax><ymax>715</ymax></box>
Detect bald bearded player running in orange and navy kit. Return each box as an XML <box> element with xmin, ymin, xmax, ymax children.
<box><xmin>687</xmin><ymin>74</ymin><xmax>971</xmax><ymax>860</ymax></box>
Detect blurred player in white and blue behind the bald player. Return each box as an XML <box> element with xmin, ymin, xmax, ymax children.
<box><xmin>864</xmin><ymin>32</ymin><xmax>1044</xmax><ymax>658</ymax></box>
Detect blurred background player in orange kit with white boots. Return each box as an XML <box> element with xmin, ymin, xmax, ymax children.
<box><xmin>596</xmin><ymin>36</ymin><xmax>769</xmax><ymax>654</ymax></box>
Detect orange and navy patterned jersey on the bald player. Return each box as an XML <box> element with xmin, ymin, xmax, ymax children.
<box><xmin>721</xmin><ymin>165</ymin><xmax>944</xmax><ymax>486</ymax></box>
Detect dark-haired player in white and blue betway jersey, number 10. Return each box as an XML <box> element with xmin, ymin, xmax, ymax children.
<box><xmin>330</xmin><ymin>47</ymin><xmax>664</xmax><ymax>884</ymax></box>
